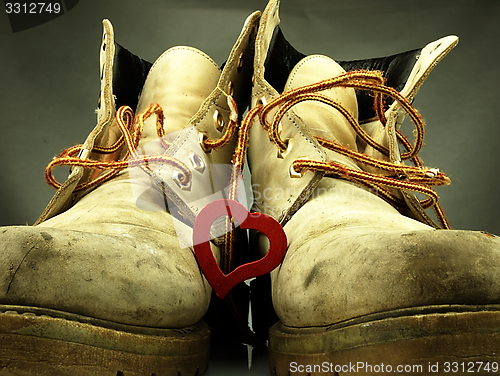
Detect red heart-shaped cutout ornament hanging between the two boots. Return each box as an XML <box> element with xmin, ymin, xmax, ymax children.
<box><xmin>193</xmin><ymin>200</ymin><xmax>287</xmax><ymax>299</ymax></box>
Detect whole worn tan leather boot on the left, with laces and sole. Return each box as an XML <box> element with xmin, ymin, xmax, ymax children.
<box><xmin>0</xmin><ymin>12</ymin><xmax>260</xmax><ymax>376</ymax></box>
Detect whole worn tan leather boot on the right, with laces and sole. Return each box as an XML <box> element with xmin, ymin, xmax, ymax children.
<box><xmin>248</xmin><ymin>0</ymin><xmax>500</xmax><ymax>375</ymax></box>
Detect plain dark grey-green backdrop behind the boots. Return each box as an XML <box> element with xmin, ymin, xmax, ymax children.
<box><xmin>0</xmin><ymin>0</ymin><xmax>500</xmax><ymax>375</ymax></box>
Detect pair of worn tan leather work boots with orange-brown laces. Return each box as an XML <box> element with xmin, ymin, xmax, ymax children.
<box><xmin>0</xmin><ymin>0</ymin><xmax>500</xmax><ymax>375</ymax></box>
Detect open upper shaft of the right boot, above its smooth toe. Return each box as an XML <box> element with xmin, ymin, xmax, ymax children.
<box><xmin>248</xmin><ymin>1</ymin><xmax>458</xmax><ymax>227</ymax></box>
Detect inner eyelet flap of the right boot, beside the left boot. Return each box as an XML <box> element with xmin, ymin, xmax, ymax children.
<box><xmin>248</xmin><ymin>3</ymin><xmax>326</xmax><ymax>225</ymax></box>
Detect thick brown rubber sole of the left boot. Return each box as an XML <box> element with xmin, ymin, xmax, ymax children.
<box><xmin>0</xmin><ymin>305</ymin><xmax>210</xmax><ymax>376</ymax></box>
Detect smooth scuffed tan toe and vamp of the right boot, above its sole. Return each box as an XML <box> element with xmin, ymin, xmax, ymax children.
<box><xmin>272</xmin><ymin>179</ymin><xmax>500</xmax><ymax>327</ymax></box>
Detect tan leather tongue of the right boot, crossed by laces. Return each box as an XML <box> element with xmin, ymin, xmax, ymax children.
<box><xmin>284</xmin><ymin>55</ymin><xmax>359</xmax><ymax>168</ymax></box>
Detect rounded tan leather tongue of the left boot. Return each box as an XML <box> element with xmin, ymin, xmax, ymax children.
<box><xmin>136</xmin><ymin>47</ymin><xmax>221</xmax><ymax>146</ymax></box>
